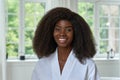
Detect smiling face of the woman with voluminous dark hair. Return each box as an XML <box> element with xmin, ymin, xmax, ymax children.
<box><xmin>53</xmin><ymin>20</ymin><xmax>73</xmax><ymax>47</ymax></box>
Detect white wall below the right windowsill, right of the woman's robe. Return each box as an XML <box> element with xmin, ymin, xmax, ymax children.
<box><xmin>95</xmin><ymin>60</ymin><xmax>120</xmax><ymax>77</ymax></box>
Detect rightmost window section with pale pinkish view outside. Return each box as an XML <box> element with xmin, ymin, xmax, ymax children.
<box><xmin>98</xmin><ymin>3</ymin><xmax>120</xmax><ymax>57</ymax></box>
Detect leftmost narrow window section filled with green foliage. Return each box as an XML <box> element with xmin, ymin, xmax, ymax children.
<box><xmin>6</xmin><ymin>0</ymin><xmax>19</xmax><ymax>58</ymax></box>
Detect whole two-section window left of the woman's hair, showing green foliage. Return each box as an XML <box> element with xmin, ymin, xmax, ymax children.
<box><xmin>6</xmin><ymin>0</ymin><xmax>46</xmax><ymax>59</ymax></box>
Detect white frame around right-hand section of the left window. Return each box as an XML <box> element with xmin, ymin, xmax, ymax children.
<box><xmin>18</xmin><ymin>0</ymin><xmax>48</xmax><ymax>59</ymax></box>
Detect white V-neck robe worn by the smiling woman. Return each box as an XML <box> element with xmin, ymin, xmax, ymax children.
<box><xmin>32</xmin><ymin>50</ymin><xmax>100</xmax><ymax>80</ymax></box>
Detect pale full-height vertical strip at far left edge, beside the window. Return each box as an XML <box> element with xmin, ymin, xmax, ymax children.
<box><xmin>0</xmin><ymin>0</ymin><xmax>6</xmax><ymax>80</ymax></box>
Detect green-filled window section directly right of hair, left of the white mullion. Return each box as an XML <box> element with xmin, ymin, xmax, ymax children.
<box><xmin>78</xmin><ymin>2</ymin><xmax>94</xmax><ymax>31</ymax></box>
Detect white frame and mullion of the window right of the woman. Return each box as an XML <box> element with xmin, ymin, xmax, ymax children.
<box><xmin>78</xmin><ymin>0</ymin><xmax>120</xmax><ymax>59</ymax></box>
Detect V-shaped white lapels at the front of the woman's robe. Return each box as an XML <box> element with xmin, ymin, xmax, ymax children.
<box><xmin>51</xmin><ymin>49</ymin><xmax>76</xmax><ymax>80</ymax></box>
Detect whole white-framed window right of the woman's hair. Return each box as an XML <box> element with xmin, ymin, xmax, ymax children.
<box><xmin>78</xmin><ymin>0</ymin><xmax>120</xmax><ymax>57</ymax></box>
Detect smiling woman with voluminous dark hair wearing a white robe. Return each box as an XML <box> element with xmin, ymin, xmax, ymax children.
<box><xmin>32</xmin><ymin>7</ymin><xmax>100</xmax><ymax>80</ymax></box>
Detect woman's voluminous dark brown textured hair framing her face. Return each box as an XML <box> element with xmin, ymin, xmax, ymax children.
<box><xmin>33</xmin><ymin>7</ymin><xmax>96</xmax><ymax>62</ymax></box>
